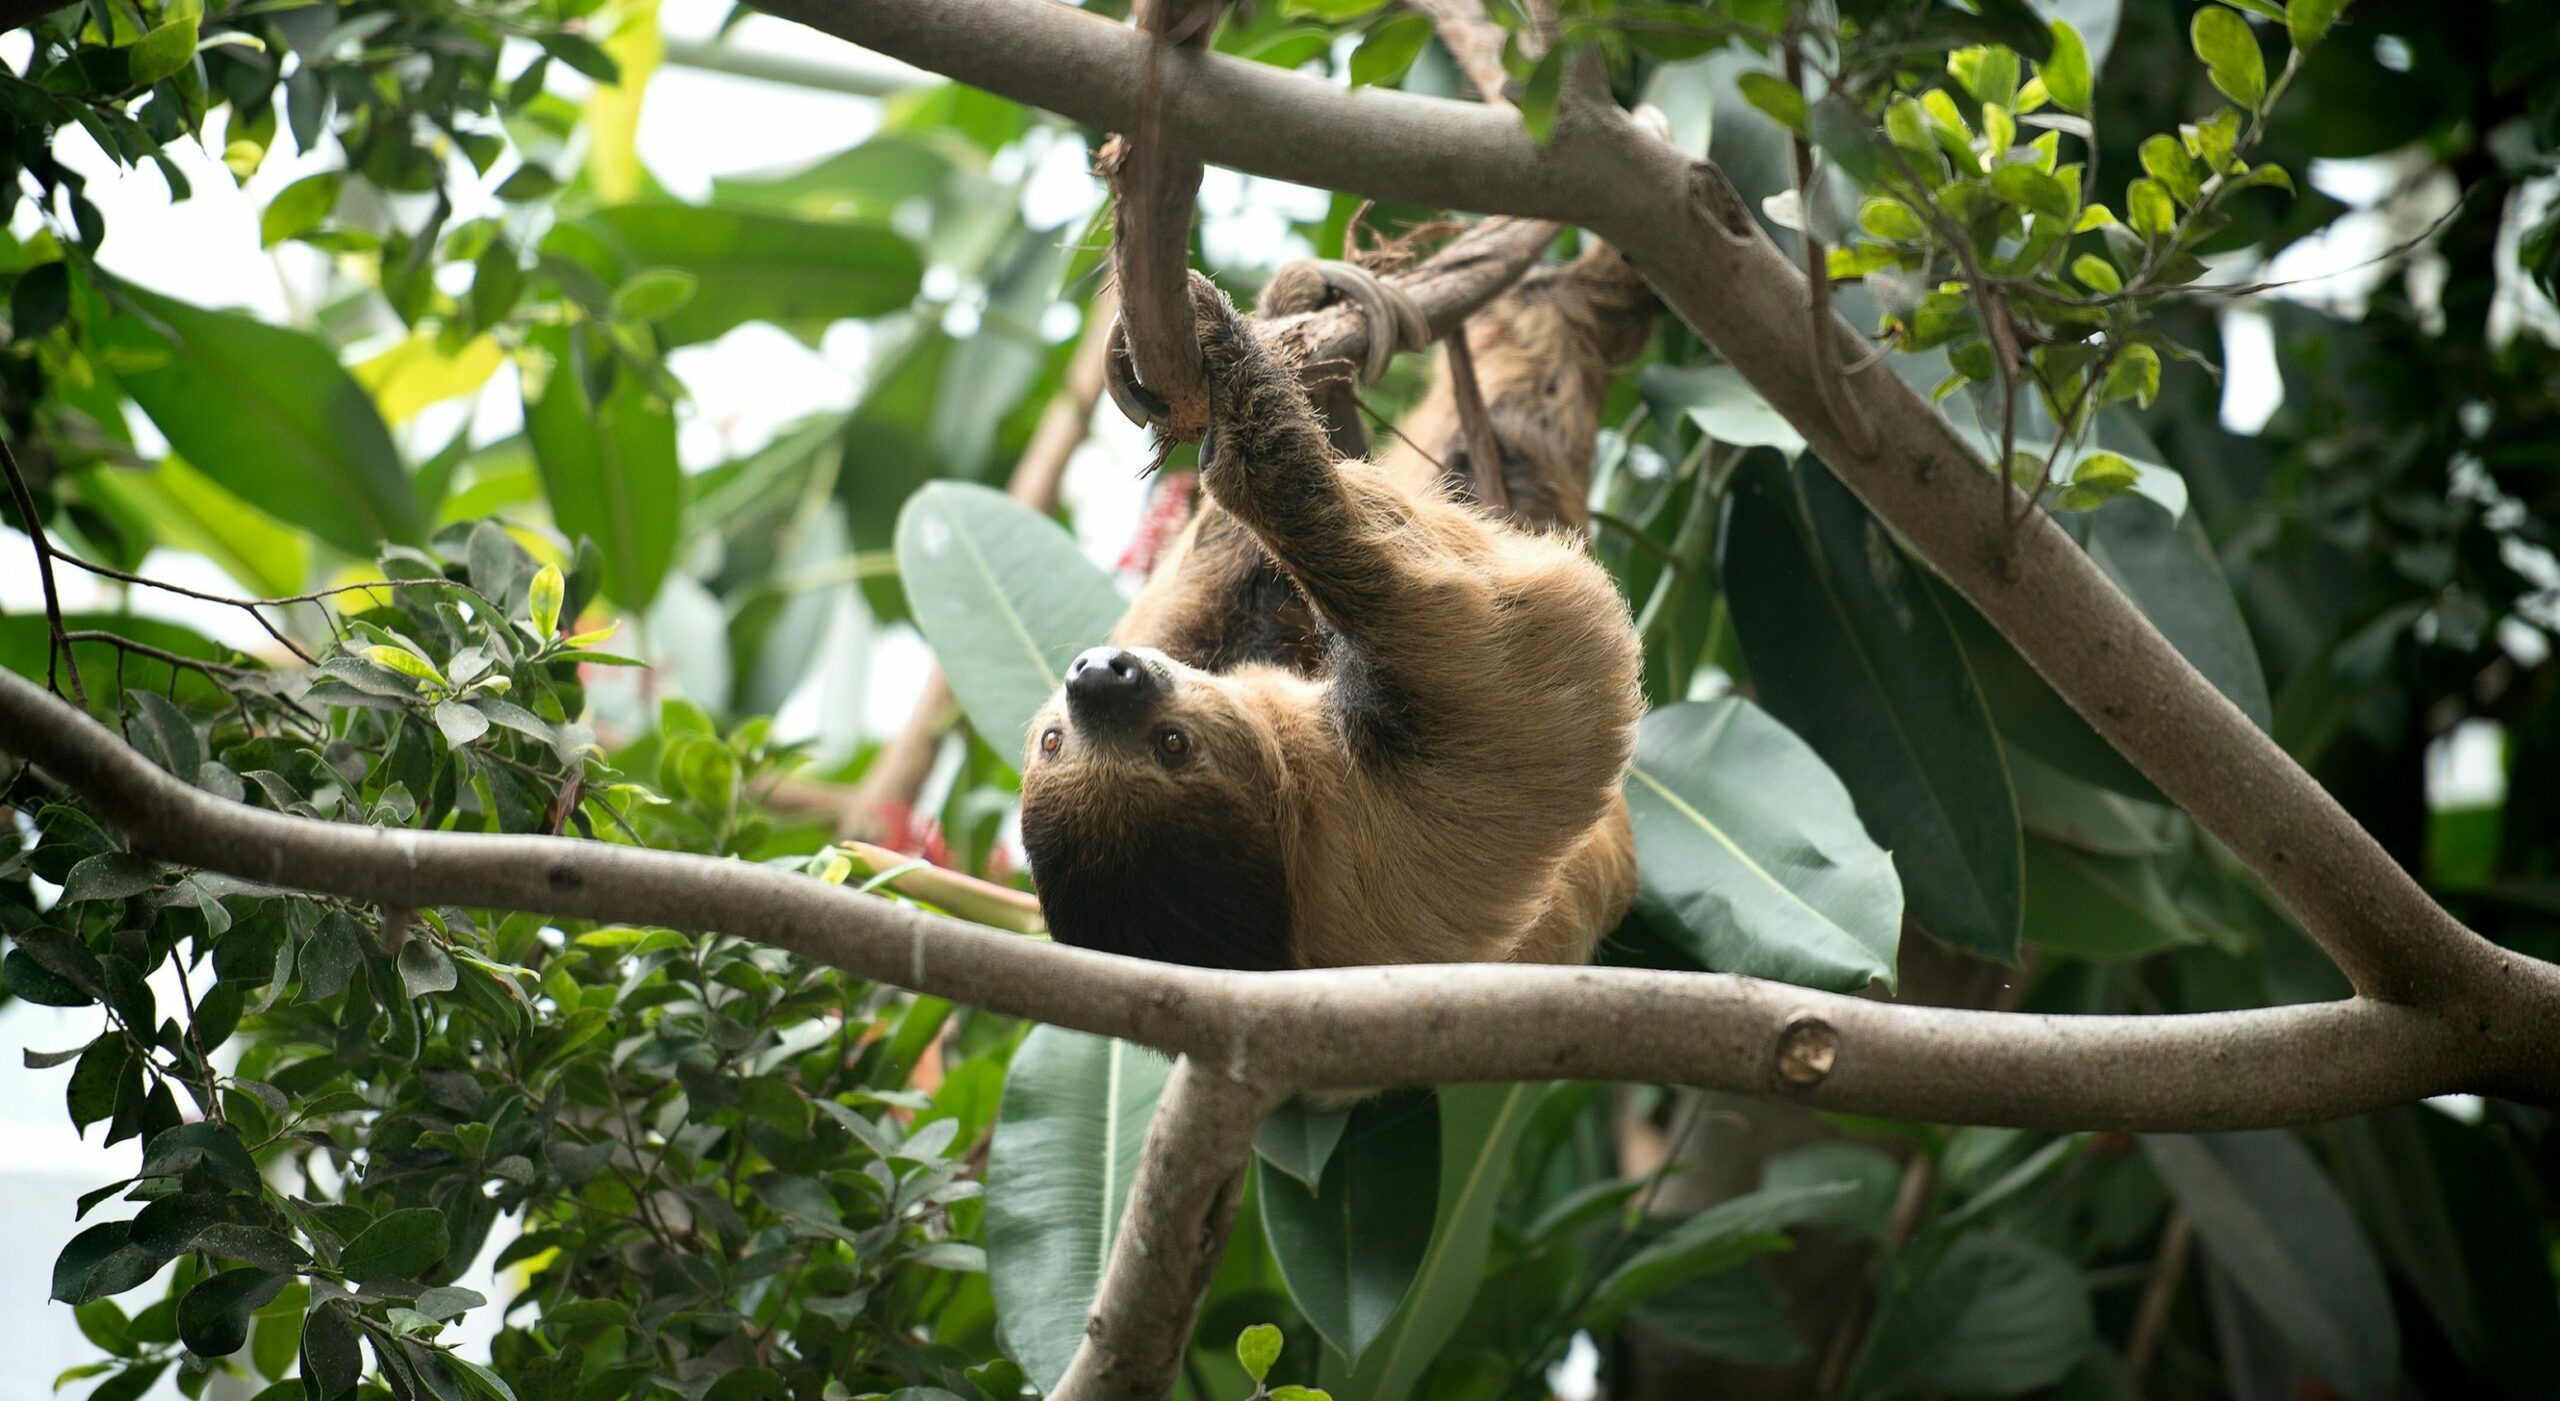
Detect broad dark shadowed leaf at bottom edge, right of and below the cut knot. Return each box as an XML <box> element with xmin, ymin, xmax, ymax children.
<box><xmin>1846</xmin><ymin>1232</ymin><xmax>2097</xmax><ymax>1398</ymax></box>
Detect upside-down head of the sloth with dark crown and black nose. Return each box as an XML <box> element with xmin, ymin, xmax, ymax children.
<box><xmin>1021</xmin><ymin>648</ymin><xmax>1295</xmax><ymax>968</ymax></box>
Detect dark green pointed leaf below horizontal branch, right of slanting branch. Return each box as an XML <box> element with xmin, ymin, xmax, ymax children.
<box><xmin>1260</xmin><ymin>1094</ymin><xmax>1441</xmax><ymax>1365</ymax></box>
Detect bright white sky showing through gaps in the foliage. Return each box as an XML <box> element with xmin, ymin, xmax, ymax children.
<box><xmin>0</xmin><ymin>0</ymin><xmax>2560</xmax><ymax>1401</ymax></box>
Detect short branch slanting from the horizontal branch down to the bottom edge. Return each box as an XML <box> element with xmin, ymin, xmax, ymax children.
<box><xmin>1050</xmin><ymin>1055</ymin><xmax>1280</xmax><ymax>1401</ymax></box>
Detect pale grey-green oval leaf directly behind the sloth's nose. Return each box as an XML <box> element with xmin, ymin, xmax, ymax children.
<box><xmin>899</xmin><ymin>482</ymin><xmax>1124</xmax><ymax>758</ymax></box>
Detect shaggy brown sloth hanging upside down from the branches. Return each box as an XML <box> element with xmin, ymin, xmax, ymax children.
<box><xmin>1021</xmin><ymin>248</ymin><xmax>1654</xmax><ymax>968</ymax></box>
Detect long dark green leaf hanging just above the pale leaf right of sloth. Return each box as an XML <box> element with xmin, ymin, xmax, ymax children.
<box><xmin>1718</xmin><ymin>453</ymin><xmax>2020</xmax><ymax>958</ymax></box>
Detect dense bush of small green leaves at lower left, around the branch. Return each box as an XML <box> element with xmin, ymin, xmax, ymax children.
<box><xmin>0</xmin><ymin>522</ymin><xmax>1019</xmax><ymax>1401</ymax></box>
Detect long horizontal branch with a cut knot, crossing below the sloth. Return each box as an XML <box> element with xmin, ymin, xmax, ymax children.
<box><xmin>0</xmin><ymin>674</ymin><xmax>2560</xmax><ymax>1132</ymax></box>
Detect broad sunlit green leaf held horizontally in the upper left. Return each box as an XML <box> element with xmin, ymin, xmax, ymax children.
<box><xmin>586</xmin><ymin>202</ymin><xmax>924</xmax><ymax>346</ymax></box>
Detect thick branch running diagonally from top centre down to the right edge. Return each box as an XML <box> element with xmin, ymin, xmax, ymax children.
<box><xmin>773</xmin><ymin>0</ymin><xmax>2560</xmax><ymax>1024</ymax></box>
